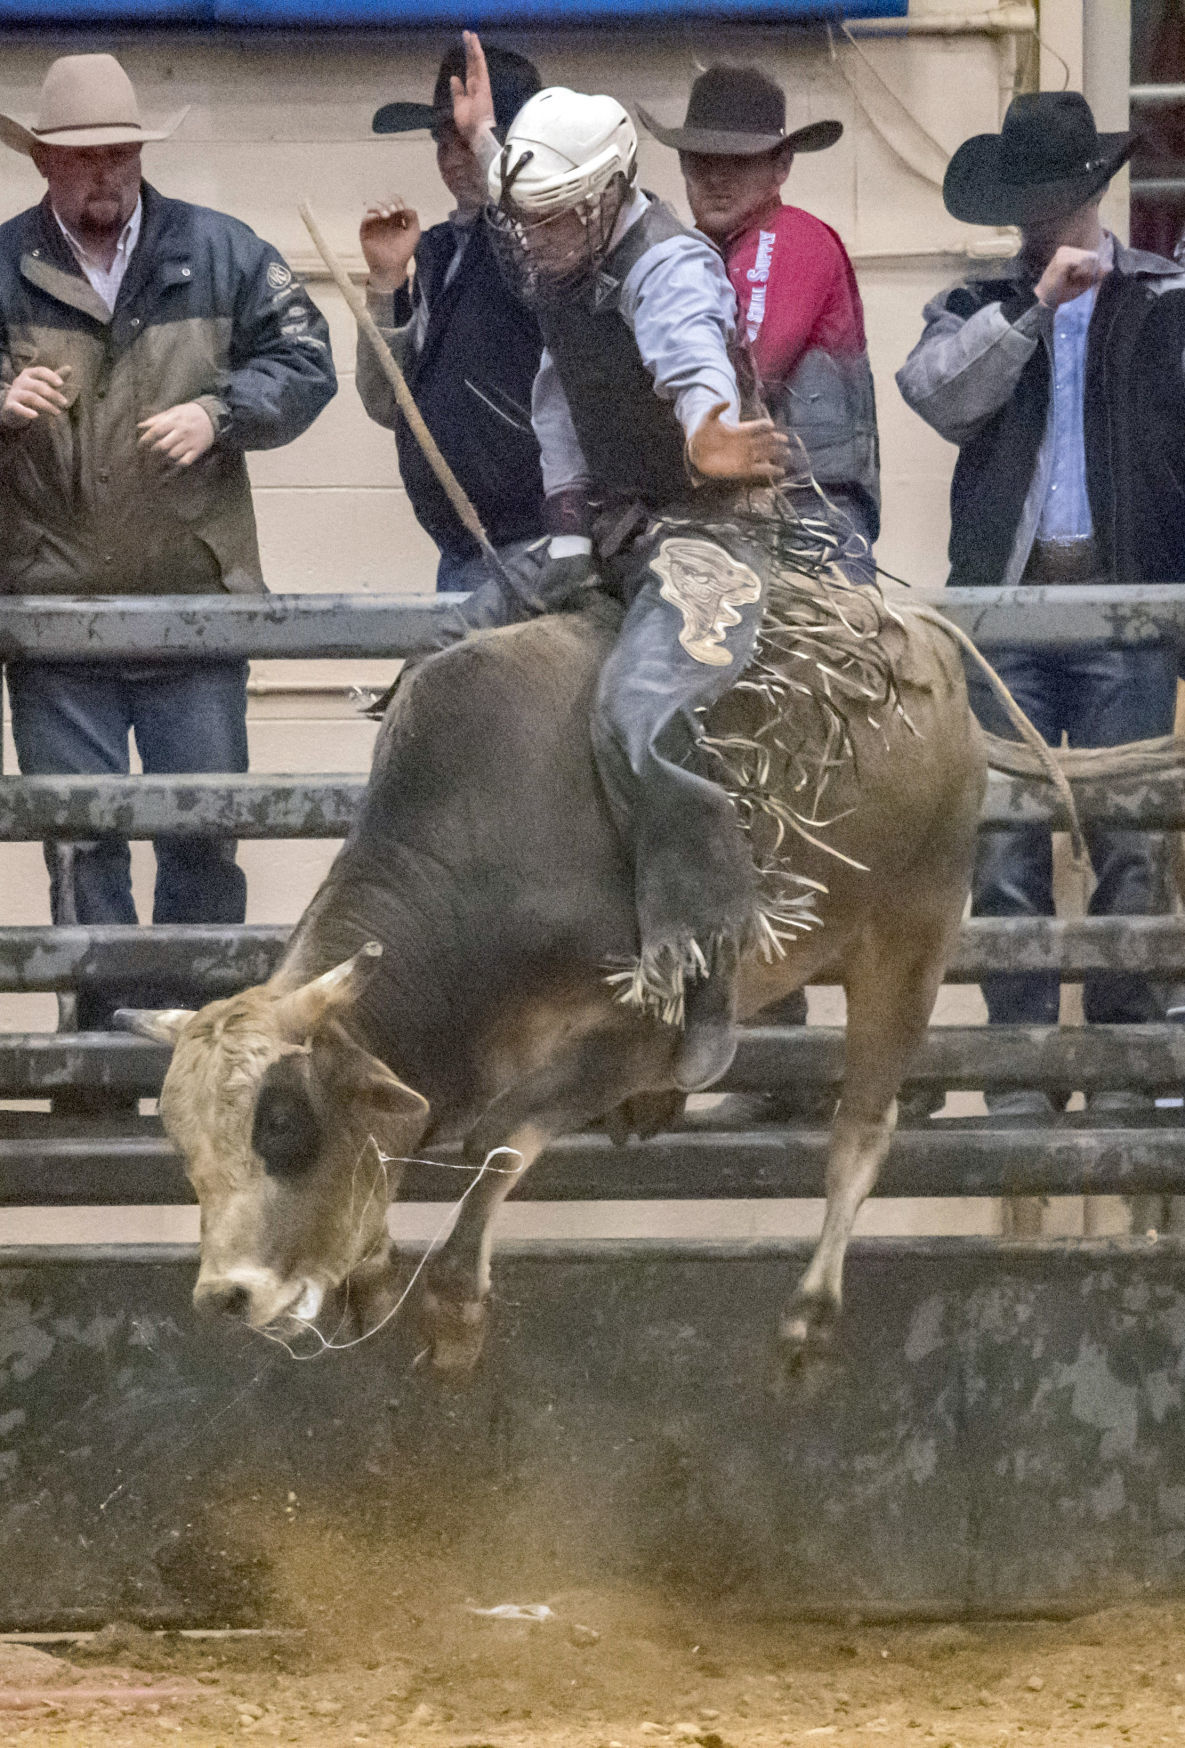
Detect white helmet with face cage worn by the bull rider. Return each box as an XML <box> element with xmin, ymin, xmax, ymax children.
<box><xmin>489</xmin><ymin>86</ymin><xmax>638</xmax><ymax>219</ymax></box>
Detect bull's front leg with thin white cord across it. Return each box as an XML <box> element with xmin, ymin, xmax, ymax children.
<box><xmin>423</xmin><ymin>1005</ymin><xmax>675</xmax><ymax>1372</ymax></box>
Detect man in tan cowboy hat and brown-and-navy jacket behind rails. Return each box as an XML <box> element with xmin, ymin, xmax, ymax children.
<box><xmin>0</xmin><ymin>54</ymin><xmax>336</xmax><ymax>1048</ymax></box>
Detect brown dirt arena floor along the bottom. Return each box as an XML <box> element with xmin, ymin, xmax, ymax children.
<box><xmin>0</xmin><ymin>1571</ymin><xmax>1185</xmax><ymax>1748</ymax></box>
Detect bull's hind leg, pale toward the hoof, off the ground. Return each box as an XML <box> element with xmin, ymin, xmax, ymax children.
<box><xmin>780</xmin><ymin>890</ymin><xmax>961</xmax><ymax>1372</ymax></box>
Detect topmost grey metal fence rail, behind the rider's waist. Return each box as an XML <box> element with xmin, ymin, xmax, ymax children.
<box><xmin>0</xmin><ymin>584</ymin><xmax>1185</xmax><ymax>661</ymax></box>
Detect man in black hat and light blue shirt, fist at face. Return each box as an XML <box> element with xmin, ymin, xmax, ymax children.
<box><xmin>897</xmin><ymin>91</ymin><xmax>1185</xmax><ymax>1112</ymax></box>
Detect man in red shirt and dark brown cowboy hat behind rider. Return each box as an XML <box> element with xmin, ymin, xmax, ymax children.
<box><xmin>638</xmin><ymin>66</ymin><xmax>881</xmax><ymax>582</ymax></box>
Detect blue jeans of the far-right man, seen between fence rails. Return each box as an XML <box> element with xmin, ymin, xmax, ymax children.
<box><xmin>968</xmin><ymin>647</ymin><xmax>1176</xmax><ymax>1026</ymax></box>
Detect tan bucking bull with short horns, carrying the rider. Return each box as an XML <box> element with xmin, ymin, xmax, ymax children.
<box><xmin>124</xmin><ymin>601</ymin><xmax>986</xmax><ymax>1367</ymax></box>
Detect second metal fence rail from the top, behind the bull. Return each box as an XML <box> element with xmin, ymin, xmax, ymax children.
<box><xmin>0</xmin><ymin>773</ymin><xmax>1185</xmax><ymax>844</ymax></box>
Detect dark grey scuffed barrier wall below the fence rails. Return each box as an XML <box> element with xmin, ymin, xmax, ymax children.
<box><xmin>0</xmin><ymin>1239</ymin><xmax>1185</xmax><ymax>1627</ymax></box>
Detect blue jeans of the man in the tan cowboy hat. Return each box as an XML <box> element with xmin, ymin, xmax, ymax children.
<box><xmin>9</xmin><ymin>661</ymin><xmax>246</xmax><ymax>1028</ymax></box>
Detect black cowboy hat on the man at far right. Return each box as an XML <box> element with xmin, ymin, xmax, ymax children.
<box><xmin>942</xmin><ymin>91</ymin><xmax>1136</xmax><ymax>225</ymax></box>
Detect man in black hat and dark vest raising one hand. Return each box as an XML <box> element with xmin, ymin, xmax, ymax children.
<box><xmin>357</xmin><ymin>42</ymin><xmax>544</xmax><ymax>589</ymax></box>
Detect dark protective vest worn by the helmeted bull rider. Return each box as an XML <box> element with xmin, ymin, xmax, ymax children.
<box><xmin>538</xmin><ymin>201</ymin><xmax>692</xmax><ymax>509</ymax></box>
